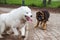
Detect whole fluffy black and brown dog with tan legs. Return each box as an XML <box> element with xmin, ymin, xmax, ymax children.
<box><xmin>35</xmin><ymin>10</ymin><xmax>50</xmax><ymax>30</ymax></box>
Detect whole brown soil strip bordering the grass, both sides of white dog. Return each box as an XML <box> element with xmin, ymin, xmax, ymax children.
<box><xmin>0</xmin><ymin>4</ymin><xmax>60</xmax><ymax>13</ymax></box>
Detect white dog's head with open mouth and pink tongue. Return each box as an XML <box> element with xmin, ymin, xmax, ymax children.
<box><xmin>21</xmin><ymin>6</ymin><xmax>32</xmax><ymax>22</ymax></box>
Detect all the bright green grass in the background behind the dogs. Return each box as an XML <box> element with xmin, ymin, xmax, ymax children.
<box><xmin>0</xmin><ymin>0</ymin><xmax>60</xmax><ymax>8</ymax></box>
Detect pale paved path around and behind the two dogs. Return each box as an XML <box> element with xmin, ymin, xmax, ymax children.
<box><xmin>0</xmin><ymin>7</ymin><xmax>60</xmax><ymax>40</ymax></box>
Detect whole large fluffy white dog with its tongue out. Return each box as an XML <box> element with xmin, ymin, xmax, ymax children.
<box><xmin>0</xmin><ymin>6</ymin><xmax>32</xmax><ymax>38</ymax></box>
